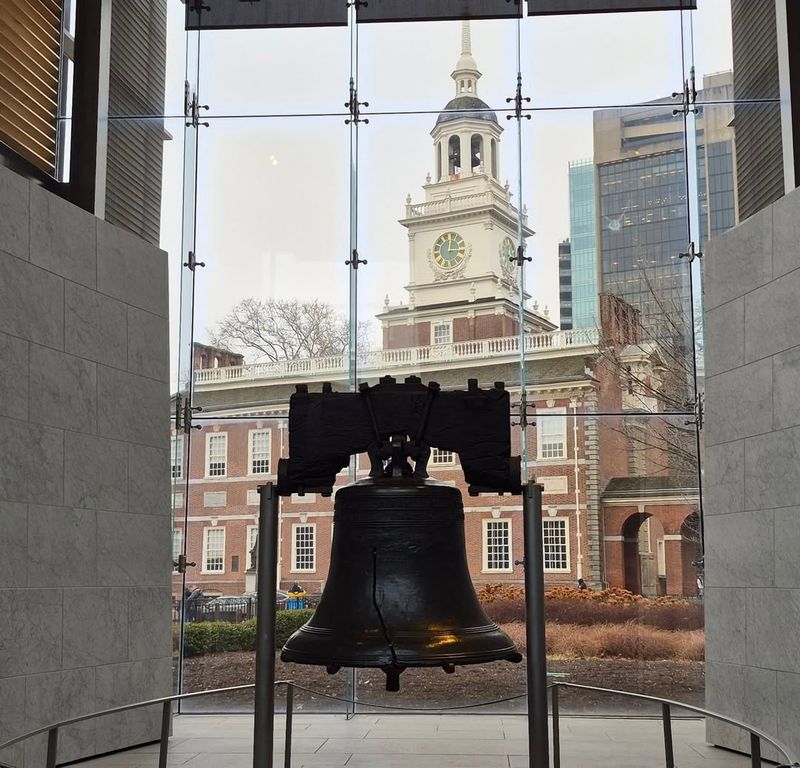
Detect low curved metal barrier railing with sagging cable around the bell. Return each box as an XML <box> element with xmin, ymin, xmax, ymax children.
<box><xmin>0</xmin><ymin>680</ymin><xmax>800</xmax><ymax>768</ymax></box>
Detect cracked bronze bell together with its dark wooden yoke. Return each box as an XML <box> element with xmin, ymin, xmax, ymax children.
<box><xmin>278</xmin><ymin>377</ymin><xmax>522</xmax><ymax>691</ymax></box>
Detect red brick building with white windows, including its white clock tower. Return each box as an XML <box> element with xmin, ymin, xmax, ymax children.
<box><xmin>173</xmin><ymin>26</ymin><xmax>696</xmax><ymax>595</ymax></box>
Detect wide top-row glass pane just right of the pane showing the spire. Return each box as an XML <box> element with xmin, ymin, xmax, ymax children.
<box><xmin>522</xmin><ymin>11</ymin><xmax>683</xmax><ymax>108</ymax></box>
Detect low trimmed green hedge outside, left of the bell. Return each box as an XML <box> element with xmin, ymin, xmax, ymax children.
<box><xmin>184</xmin><ymin>608</ymin><xmax>314</xmax><ymax>656</ymax></box>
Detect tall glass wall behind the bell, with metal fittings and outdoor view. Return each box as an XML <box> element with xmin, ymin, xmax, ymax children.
<box><xmin>117</xmin><ymin>0</ymin><xmax>779</xmax><ymax>712</ymax></box>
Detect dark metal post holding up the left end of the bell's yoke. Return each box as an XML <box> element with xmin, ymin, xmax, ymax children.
<box><xmin>253</xmin><ymin>483</ymin><xmax>278</xmax><ymax>768</ymax></box>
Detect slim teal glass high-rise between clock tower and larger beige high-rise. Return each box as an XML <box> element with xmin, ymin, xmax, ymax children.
<box><xmin>569</xmin><ymin>160</ymin><xmax>600</xmax><ymax>328</ymax></box>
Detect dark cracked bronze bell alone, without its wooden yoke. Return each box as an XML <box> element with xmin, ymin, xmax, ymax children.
<box><xmin>281</xmin><ymin>476</ymin><xmax>522</xmax><ymax>691</ymax></box>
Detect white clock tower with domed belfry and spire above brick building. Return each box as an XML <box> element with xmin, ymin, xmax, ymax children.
<box><xmin>378</xmin><ymin>21</ymin><xmax>556</xmax><ymax>349</ymax></box>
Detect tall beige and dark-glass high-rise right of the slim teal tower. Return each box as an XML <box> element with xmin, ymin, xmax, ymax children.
<box><xmin>594</xmin><ymin>72</ymin><xmax>737</xmax><ymax>342</ymax></box>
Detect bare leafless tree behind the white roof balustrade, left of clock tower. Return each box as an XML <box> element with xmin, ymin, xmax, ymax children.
<box><xmin>211</xmin><ymin>298</ymin><xmax>369</xmax><ymax>362</ymax></box>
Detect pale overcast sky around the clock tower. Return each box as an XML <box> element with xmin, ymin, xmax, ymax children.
<box><xmin>162</xmin><ymin>0</ymin><xmax>732</xmax><ymax>370</ymax></box>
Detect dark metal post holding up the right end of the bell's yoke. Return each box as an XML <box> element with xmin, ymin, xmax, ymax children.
<box><xmin>522</xmin><ymin>483</ymin><xmax>550</xmax><ymax>768</ymax></box>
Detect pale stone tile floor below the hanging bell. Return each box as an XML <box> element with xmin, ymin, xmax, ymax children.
<box><xmin>72</xmin><ymin>715</ymin><xmax>750</xmax><ymax>768</ymax></box>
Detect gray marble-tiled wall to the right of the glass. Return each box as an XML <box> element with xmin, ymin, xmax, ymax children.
<box><xmin>704</xmin><ymin>190</ymin><xmax>800</xmax><ymax>757</ymax></box>
